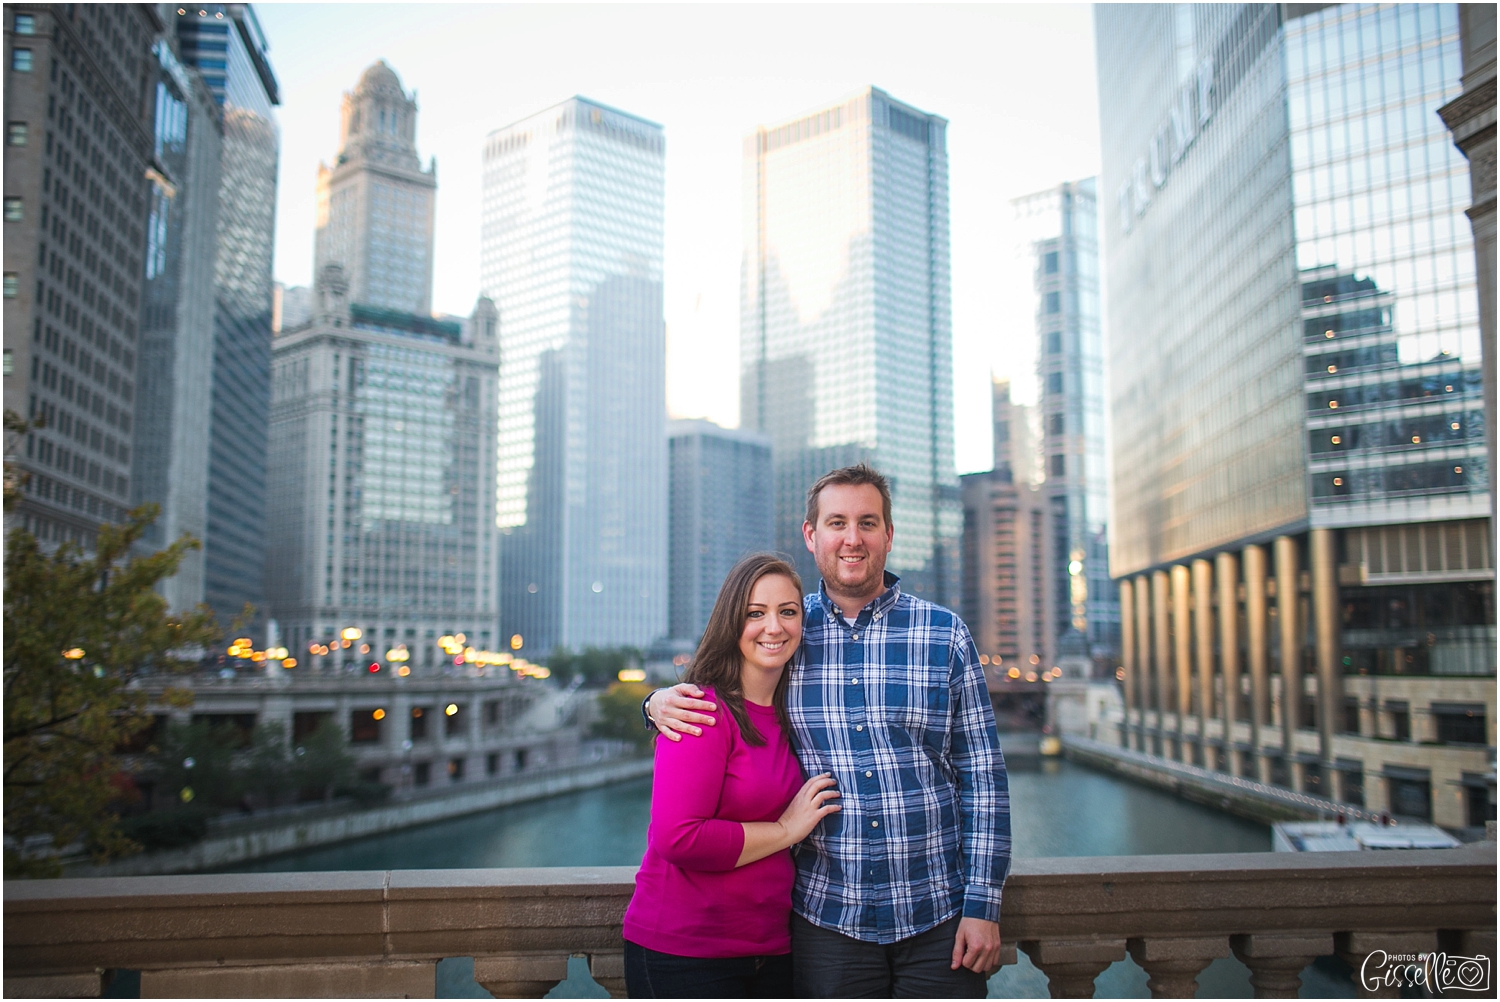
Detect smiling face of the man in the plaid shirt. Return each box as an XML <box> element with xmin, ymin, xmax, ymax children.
<box><xmin>803</xmin><ymin>483</ymin><xmax>893</xmax><ymax>600</ymax></box>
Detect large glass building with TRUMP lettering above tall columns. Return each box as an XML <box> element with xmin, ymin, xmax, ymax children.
<box><xmin>1095</xmin><ymin>5</ymin><xmax>1496</xmax><ymax>827</ymax></box>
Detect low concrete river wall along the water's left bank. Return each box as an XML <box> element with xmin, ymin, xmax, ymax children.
<box><xmin>68</xmin><ymin>756</ymin><xmax>654</xmax><ymax>878</ymax></box>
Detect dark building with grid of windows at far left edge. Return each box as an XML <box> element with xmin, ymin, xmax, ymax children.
<box><xmin>5</xmin><ymin>3</ymin><xmax>162</xmax><ymax>548</ymax></box>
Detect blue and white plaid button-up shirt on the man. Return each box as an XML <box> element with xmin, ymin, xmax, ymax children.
<box><xmin>788</xmin><ymin>573</ymin><xmax>1011</xmax><ymax>944</ymax></box>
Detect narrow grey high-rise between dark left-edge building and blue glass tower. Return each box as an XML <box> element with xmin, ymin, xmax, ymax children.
<box><xmin>131</xmin><ymin>33</ymin><xmax>224</xmax><ymax>611</ymax></box>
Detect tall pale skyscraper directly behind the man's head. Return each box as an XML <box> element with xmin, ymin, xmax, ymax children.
<box><xmin>740</xmin><ymin>87</ymin><xmax>962</xmax><ymax>605</ymax></box>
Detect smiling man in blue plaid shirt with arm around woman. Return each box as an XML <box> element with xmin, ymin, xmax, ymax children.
<box><xmin>647</xmin><ymin>464</ymin><xmax>1011</xmax><ymax>998</ymax></box>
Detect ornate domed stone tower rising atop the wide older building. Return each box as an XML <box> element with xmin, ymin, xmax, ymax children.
<box><xmin>312</xmin><ymin>60</ymin><xmax>438</xmax><ymax>315</ymax></box>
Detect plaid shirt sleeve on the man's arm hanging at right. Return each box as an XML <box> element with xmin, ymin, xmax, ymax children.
<box><xmin>950</xmin><ymin>617</ymin><xmax>1011</xmax><ymax>923</ymax></box>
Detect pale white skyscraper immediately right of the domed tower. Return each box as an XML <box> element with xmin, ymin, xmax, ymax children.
<box><xmin>480</xmin><ymin>98</ymin><xmax>668</xmax><ymax>653</ymax></box>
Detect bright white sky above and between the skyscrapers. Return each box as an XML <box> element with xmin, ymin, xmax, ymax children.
<box><xmin>255</xmin><ymin>3</ymin><xmax>1100</xmax><ymax>473</ymax></box>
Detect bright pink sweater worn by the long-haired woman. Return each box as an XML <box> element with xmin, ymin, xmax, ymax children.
<box><xmin>624</xmin><ymin>690</ymin><xmax>803</xmax><ymax>957</ymax></box>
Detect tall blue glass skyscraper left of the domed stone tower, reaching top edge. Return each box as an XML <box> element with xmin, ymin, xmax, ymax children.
<box><xmin>177</xmin><ymin>3</ymin><xmax>281</xmax><ymax>626</ymax></box>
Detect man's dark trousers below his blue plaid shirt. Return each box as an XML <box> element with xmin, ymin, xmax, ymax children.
<box><xmin>792</xmin><ymin>914</ymin><xmax>987</xmax><ymax>999</ymax></box>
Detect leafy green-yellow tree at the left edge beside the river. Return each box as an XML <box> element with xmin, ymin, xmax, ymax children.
<box><xmin>5</xmin><ymin>506</ymin><xmax>219</xmax><ymax>876</ymax></box>
